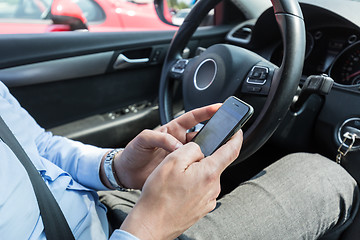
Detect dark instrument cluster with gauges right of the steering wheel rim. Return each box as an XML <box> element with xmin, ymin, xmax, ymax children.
<box><xmin>296</xmin><ymin>27</ymin><xmax>360</xmax><ymax>86</ymax></box>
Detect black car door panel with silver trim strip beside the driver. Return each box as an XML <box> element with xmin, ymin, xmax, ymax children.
<box><xmin>0</xmin><ymin>27</ymin><xmax>228</xmax><ymax>147</ymax></box>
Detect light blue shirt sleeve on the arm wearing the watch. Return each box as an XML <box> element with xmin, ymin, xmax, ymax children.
<box><xmin>0</xmin><ymin>82</ymin><xmax>109</xmax><ymax>190</ymax></box>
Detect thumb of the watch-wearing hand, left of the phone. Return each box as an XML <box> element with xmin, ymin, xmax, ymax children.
<box><xmin>134</xmin><ymin>130</ymin><xmax>182</xmax><ymax>152</ymax></box>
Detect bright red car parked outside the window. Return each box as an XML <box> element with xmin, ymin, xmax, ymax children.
<box><xmin>0</xmin><ymin>0</ymin><xmax>177</xmax><ymax>34</ymax></box>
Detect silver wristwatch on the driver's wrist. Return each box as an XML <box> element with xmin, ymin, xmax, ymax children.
<box><xmin>104</xmin><ymin>148</ymin><xmax>131</xmax><ymax>192</ymax></box>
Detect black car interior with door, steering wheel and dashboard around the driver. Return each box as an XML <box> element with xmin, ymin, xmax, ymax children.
<box><xmin>0</xmin><ymin>0</ymin><xmax>360</xmax><ymax>239</ymax></box>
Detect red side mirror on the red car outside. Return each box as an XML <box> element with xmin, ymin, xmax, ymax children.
<box><xmin>50</xmin><ymin>0</ymin><xmax>88</xmax><ymax>31</ymax></box>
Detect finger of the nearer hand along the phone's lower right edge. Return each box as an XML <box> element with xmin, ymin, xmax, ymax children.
<box><xmin>206</xmin><ymin>129</ymin><xmax>243</xmax><ymax>174</ymax></box>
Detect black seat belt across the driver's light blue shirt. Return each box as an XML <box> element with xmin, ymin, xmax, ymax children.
<box><xmin>0</xmin><ymin>116</ymin><xmax>75</xmax><ymax>240</ymax></box>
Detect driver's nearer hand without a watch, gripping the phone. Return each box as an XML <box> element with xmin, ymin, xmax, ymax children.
<box><xmin>121</xmin><ymin>130</ymin><xmax>242</xmax><ymax>240</ymax></box>
